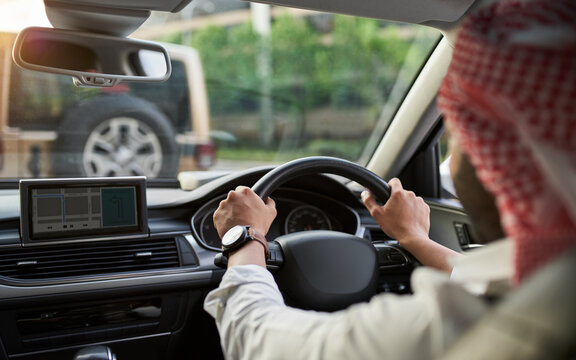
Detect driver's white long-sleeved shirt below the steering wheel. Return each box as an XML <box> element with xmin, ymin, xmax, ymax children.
<box><xmin>204</xmin><ymin>242</ymin><xmax>510</xmax><ymax>360</ymax></box>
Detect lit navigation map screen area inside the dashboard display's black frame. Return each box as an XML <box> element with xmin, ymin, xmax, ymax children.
<box><xmin>32</xmin><ymin>186</ymin><xmax>138</xmax><ymax>234</ymax></box>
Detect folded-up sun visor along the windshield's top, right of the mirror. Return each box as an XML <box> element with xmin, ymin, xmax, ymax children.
<box><xmin>243</xmin><ymin>0</ymin><xmax>475</xmax><ymax>25</ymax></box>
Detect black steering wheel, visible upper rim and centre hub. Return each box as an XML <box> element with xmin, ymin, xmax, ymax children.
<box><xmin>252</xmin><ymin>156</ymin><xmax>390</xmax><ymax>311</ymax></box>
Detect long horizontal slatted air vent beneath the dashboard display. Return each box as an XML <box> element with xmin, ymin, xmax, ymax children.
<box><xmin>0</xmin><ymin>238</ymin><xmax>180</xmax><ymax>280</ymax></box>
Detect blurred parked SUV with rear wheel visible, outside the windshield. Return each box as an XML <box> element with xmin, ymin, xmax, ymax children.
<box><xmin>0</xmin><ymin>33</ymin><xmax>215</xmax><ymax>178</ymax></box>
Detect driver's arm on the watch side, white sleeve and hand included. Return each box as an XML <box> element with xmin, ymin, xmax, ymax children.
<box><xmin>204</xmin><ymin>183</ymin><xmax>478</xmax><ymax>360</ymax></box>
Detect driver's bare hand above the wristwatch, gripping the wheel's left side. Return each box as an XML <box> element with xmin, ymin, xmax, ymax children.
<box><xmin>214</xmin><ymin>186</ymin><xmax>276</xmax><ymax>238</ymax></box>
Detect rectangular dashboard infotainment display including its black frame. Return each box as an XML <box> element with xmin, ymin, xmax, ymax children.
<box><xmin>20</xmin><ymin>177</ymin><xmax>147</xmax><ymax>245</ymax></box>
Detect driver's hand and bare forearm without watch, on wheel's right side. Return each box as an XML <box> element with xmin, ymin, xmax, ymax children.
<box><xmin>362</xmin><ymin>178</ymin><xmax>460</xmax><ymax>272</ymax></box>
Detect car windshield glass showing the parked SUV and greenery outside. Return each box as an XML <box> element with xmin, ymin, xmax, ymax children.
<box><xmin>0</xmin><ymin>0</ymin><xmax>439</xmax><ymax>184</ymax></box>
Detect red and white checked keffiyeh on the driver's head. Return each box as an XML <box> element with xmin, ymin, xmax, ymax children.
<box><xmin>438</xmin><ymin>0</ymin><xmax>576</xmax><ymax>282</ymax></box>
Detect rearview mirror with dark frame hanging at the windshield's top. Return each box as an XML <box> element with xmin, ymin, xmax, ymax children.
<box><xmin>12</xmin><ymin>27</ymin><xmax>172</xmax><ymax>87</ymax></box>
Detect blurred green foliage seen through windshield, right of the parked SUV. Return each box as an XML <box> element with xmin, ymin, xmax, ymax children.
<box><xmin>164</xmin><ymin>14</ymin><xmax>438</xmax><ymax>161</ymax></box>
